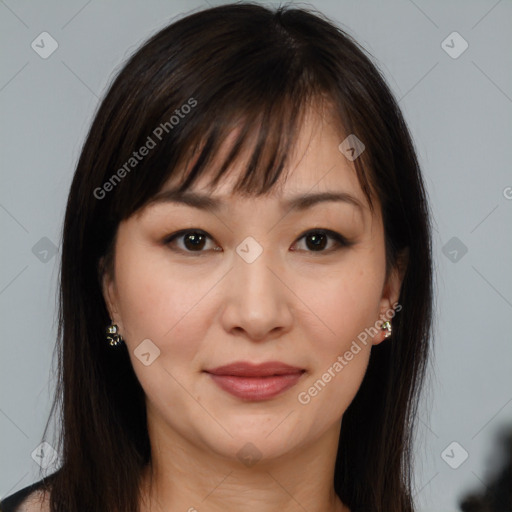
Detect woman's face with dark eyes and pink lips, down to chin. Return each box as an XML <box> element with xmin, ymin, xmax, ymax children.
<box><xmin>104</xmin><ymin>110</ymin><xmax>401</xmax><ymax>462</ymax></box>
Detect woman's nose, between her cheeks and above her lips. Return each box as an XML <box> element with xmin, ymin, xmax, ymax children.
<box><xmin>221</xmin><ymin>246</ymin><xmax>294</xmax><ymax>341</ymax></box>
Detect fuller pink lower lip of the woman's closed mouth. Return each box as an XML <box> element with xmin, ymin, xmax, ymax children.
<box><xmin>209</xmin><ymin>373</ymin><xmax>302</xmax><ymax>401</ymax></box>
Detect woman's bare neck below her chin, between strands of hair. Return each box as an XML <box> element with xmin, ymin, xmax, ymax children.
<box><xmin>141</xmin><ymin>416</ymin><xmax>350</xmax><ymax>512</ymax></box>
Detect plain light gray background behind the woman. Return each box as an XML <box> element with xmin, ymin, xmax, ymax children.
<box><xmin>0</xmin><ymin>0</ymin><xmax>512</xmax><ymax>512</ymax></box>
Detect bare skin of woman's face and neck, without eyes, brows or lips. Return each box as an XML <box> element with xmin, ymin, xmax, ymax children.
<box><xmin>99</xmin><ymin>107</ymin><xmax>403</xmax><ymax>512</ymax></box>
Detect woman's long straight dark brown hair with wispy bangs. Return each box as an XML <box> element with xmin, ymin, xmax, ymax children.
<box><xmin>36</xmin><ymin>3</ymin><xmax>433</xmax><ymax>512</ymax></box>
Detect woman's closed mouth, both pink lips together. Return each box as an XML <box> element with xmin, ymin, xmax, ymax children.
<box><xmin>205</xmin><ymin>361</ymin><xmax>306</xmax><ymax>401</ymax></box>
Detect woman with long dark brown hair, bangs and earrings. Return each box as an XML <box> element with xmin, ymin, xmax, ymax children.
<box><xmin>2</xmin><ymin>4</ymin><xmax>433</xmax><ymax>512</ymax></box>
